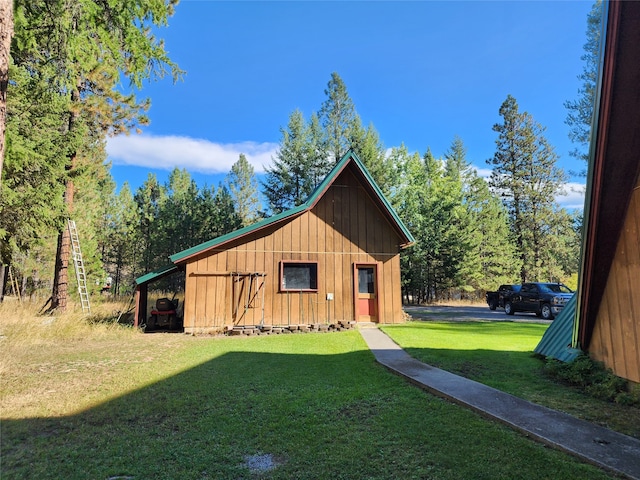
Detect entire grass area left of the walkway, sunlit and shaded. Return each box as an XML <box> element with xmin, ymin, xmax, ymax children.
<box><xmin>0</xmin><ymin>306</ymin><xmax>632</xmax><ymax>479</ymax></box>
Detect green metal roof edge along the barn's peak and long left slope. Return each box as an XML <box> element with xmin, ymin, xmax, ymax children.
<box><xmin>169</xmin><ymin>150</ymin><xmax>415</xmax><ymax>263</ymax></box>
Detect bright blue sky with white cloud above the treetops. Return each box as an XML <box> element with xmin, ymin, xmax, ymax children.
<box><xmin>107</xmin><ymin>0</ymin><xmax>592</xmax><ymax>207</ymax></box>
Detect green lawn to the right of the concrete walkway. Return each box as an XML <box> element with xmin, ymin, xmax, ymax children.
<box><xmin>382</xmin><ymin>322</ymin><xmax>640</xmax><ymax>438</ymax></box>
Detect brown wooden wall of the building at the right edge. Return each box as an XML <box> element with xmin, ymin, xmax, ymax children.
<box><xmin>588</xmin><ymin>179</ymin><xmax>640</xmax><ymax>382</ymax></box>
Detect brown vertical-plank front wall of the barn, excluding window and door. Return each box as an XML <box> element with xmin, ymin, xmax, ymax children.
<box><xmin>184</xmin><ymin>169</ymin><xmax>402</xmax><ymax>331</ymax></box>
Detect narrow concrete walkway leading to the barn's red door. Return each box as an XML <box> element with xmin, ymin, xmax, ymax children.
<box><xmin>360</xmin><ymin>327</ymin><xmax>640</xmax><ymax>480</ymax></box>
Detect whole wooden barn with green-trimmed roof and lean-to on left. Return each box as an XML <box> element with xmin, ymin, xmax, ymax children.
<box><xmin>136</xmin><ymin>151</ymin><xmax>414</xmax><ymax>333</ymax></box>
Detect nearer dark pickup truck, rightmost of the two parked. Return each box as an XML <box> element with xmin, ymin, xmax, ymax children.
<box><xmin>504</xmin><ymin>282</ymin><xmax>573</xmax><ymax>320</ymax></box>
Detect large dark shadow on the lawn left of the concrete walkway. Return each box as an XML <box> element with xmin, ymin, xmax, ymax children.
<box><xmin>2</xmin><ymin>350</ymin><xmax>608</xmax><ymax>479</ymax></box>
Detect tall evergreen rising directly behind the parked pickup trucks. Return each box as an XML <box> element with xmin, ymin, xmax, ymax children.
<box><xmin>487</xmin><ymin>95</ymin><xmax>566</xmax><ymax>282</ymax></box>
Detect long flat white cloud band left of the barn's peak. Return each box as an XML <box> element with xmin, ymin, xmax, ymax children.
<box><xmin>107</xmin><ymin>135</ymin><xmax>278</xmax><ymax>174</ymax></box>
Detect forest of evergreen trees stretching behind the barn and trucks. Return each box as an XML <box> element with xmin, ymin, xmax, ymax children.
<box><xmin>0</xmin><ymin>0</ymin><xmax>600</xmax><ymax>309</ymax></box>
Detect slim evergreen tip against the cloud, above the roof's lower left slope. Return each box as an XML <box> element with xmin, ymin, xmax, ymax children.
<box><xmin>227</xmin><ymin>153</ymin><xmax>260</xmax><ymax>227</ymax></box>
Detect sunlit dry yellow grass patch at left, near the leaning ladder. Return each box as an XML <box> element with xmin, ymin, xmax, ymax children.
<box><xmin>0</xmin><ymin>303</ymin><xmax>195</xmax><ymax>418</ymax></box>
